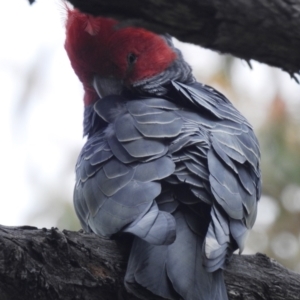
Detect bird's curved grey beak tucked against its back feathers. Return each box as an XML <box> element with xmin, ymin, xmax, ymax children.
<box><xmin>92</xmin><ymin>75</ymin><xmax>123</xmax><ymax>98</ymax></box>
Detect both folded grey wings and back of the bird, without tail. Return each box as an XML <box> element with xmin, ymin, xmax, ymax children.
<box><xmin>74</xmin><ymin>82</ymin><xmax>260</xmax><ymax>271</ymax></box>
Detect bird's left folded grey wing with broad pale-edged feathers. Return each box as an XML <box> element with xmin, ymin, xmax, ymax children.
<box><xmin>74</xmin><ymin>96</ymin><xmax>182</xmax><ymax>244</ymax></box>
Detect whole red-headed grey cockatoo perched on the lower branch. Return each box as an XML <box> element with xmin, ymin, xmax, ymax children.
<box><xmin>65</xmin><ymin>9</ymin><xmax>261</xmax><ymax>300</ymax></box>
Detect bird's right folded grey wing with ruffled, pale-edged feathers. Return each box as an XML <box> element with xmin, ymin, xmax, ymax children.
<box><xmin>173</xmin><ymin>82</ymin><xmax>261</xmax><ymax>271</ymax></box>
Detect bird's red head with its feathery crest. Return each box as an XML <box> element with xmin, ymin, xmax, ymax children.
<box><xmin>65</xmin><ymin>10</ymin><xmax>177</xmax><ymax>105</ymax></box>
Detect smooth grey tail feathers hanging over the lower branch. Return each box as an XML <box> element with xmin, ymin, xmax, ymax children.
<box><xmin>125</xmin><ymin>211</ymin><xmax>228</xmax><ymax>300</ymax></box>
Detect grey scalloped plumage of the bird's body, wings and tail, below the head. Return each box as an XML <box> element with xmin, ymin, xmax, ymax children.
<box><xmin>74</xmin><ymin>76</ymin><xmax>261</xmax><ymax>300</ymax></box>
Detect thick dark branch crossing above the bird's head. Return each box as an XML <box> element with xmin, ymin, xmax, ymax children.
<box><xmin>68</xmin><ymin>0</ymin><xmax>300</xmax><ymax>75</ymax></box>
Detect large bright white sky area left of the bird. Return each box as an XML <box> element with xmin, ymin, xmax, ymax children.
<box><xmin>0</xmin><ymin>0</ymin><xmax>83</xmax><ymax>226</ymax></box>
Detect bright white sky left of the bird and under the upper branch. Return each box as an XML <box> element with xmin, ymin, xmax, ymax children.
<box><xmin>0</xmin><ymin>0</ymin><xmax>300</xmax><ymax>232</ymax></box>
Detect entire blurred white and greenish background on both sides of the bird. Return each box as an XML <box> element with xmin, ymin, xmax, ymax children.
<box><xmin>0</xmin><ymin>0</ymin><xmax>300</xmax><ymax>272</ymax></box>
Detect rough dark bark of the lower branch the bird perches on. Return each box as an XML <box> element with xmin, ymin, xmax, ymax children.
<box><xmin>0</xmin><ymin>226</ymin><xmax>300</xmax><ymax>300</ymax></box>
